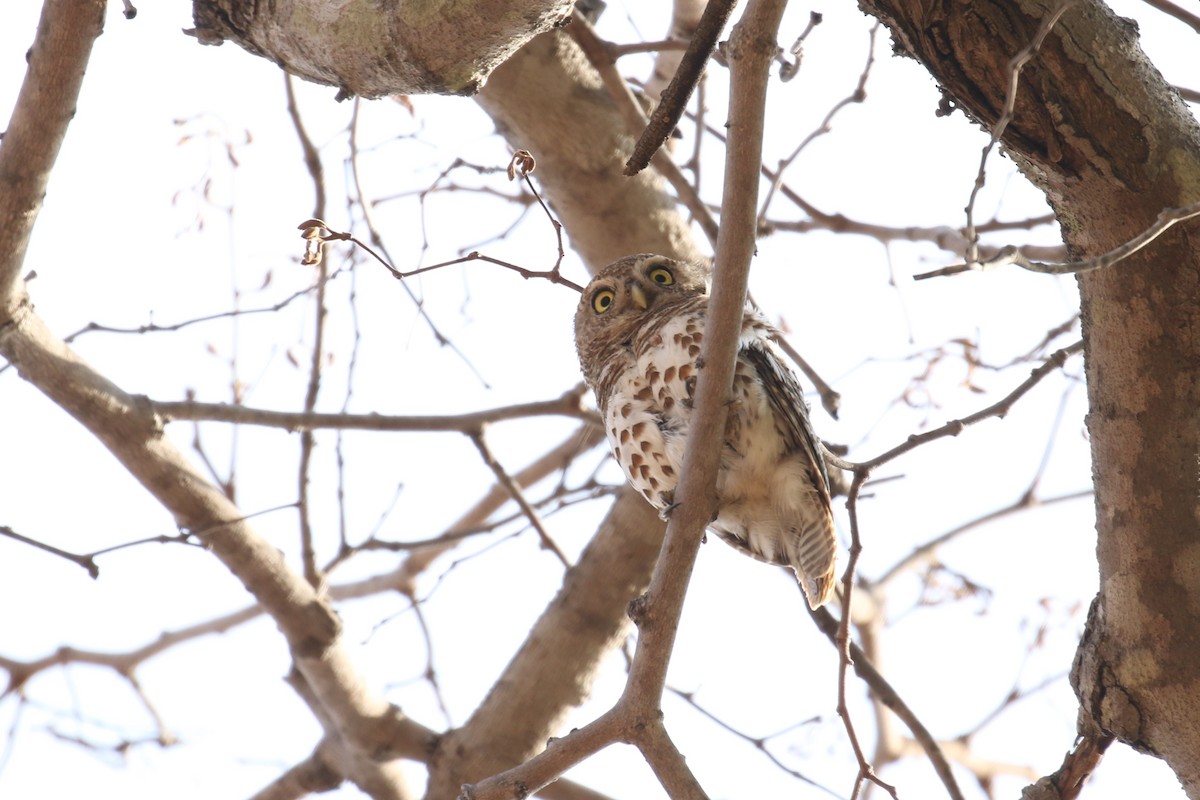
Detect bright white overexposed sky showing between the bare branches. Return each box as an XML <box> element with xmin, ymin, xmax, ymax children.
<box><xmin>0</xmin><ymin>2</ymin><xmax>1195</xmax><ymax>799</ymax></box>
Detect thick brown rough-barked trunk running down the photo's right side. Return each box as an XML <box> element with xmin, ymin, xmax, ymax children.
<box><xmin>863</xmin><ymin>0</ymin><xmax>1200</xmax><ymax>798</ymax></box>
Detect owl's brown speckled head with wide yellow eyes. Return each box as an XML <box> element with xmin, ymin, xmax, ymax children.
<box><xmin>575</xmin><ymin>253</ymin><xmax>708</xmax><ymax>384</ymax></box>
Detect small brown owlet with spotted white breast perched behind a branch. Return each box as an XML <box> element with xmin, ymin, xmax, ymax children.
<box><xmin>575</xmin><ymin>253</ymin><xmax>835</xmax><ymax>608</ymax></box>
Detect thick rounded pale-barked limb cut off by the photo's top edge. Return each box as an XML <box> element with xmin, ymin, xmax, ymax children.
<box><xmin>188</xmin><ymin>0</ymin><xmax>571</xmax><ymax>97</ymax></box>
